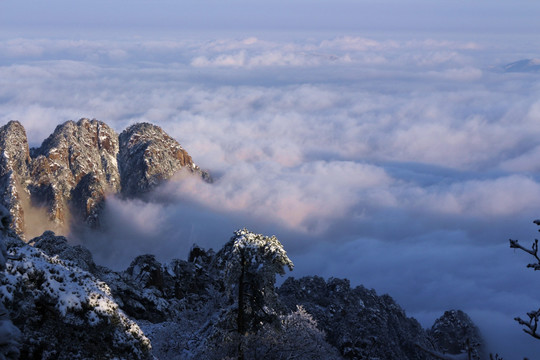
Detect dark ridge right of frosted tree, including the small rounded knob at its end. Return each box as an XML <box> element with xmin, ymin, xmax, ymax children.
<box><xmin>278</xmin><ymin>276</ymin><xmax>483</xmax><ymax>359</ymax></box>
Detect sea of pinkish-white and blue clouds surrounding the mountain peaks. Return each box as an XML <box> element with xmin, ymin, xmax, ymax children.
<box><xmin>0</xmin><ymin>34</ymin><xmax>540</xmax><ymax>358</ymax></box>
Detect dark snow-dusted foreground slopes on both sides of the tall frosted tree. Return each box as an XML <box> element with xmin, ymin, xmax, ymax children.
<box><xmin>0</xmin><ymin>226</ymin><xmax>483</xmax><ymax>360</ymax></box>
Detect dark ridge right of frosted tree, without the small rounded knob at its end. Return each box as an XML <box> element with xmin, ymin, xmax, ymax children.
<box><xmin>278</xmin><ymin>276</ymin><xmax>433</xmax><ymax>360</ymax></box>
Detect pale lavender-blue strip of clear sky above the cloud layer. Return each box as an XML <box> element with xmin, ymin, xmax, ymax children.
<box><xmin>0</xmin><ymin>0</ymin><xmax>540</xmax><ymax>33</ymax></box>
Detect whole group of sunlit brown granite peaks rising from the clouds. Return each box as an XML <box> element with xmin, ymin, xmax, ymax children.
<box><xmin>0</xmin><ymin>119</ymin><xmax>210</xmax><ymax>234</ymax></box>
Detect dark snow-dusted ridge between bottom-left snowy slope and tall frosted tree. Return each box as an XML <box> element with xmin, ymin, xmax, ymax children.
<box><xmin>29</xmin><ymin>231</ymin><xmax>218</xmax><ymax>323</ymax></box>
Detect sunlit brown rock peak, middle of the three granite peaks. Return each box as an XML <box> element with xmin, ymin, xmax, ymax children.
<box><xmin>27</xmin><ymin>119</ymin><xmax>120</xmax><ymax>229</ymax></box>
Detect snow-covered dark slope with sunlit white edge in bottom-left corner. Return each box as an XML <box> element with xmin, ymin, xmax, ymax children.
<box><xmin>0</xmin><ymin>234</ymin><xmax>151</xmax><ymax>359</ymax></box>
